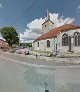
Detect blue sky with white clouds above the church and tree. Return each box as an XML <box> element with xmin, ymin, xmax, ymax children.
<box><xmin>0</xmin><ymin>0</ymin><xmax>80</xmax><ymax>42</ymax></box>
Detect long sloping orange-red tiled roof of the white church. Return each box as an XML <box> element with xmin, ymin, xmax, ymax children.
<box><xmin>34</xmin><ymin>24</ymin><xmax>80</xmax><ymax>42</ymax></box>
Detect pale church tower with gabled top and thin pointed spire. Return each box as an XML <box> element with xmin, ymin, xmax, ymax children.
<box><xmin>42</xmin><ymin>10</ymin><xmax>54</xmax><ymax>34</ymax></box>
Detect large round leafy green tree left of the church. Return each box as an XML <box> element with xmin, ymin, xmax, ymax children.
<box><xmin>0</xmin><ymin>27</ymin><xmax>19</xmax><ymax>47</ymax></box>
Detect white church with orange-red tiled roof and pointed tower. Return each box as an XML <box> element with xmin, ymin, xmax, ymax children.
<box><xmin>33</xmin><ymin>12</ymin><xmax>80</xmax><ymax>53</ymax></box>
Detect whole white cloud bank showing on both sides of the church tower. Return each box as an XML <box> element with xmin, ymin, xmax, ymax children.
<box><xmin>20</xmin><ymin>13</ymin><xmax>75</xmax><ymax>42</ymax></box>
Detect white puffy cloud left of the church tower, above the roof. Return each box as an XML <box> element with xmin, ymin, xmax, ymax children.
<box><xmin>20</xmin><ymin>18</ymin><xmax>45</xmax><ymax>42</ymax></box>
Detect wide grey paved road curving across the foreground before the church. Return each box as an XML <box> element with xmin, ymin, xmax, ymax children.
<box><xmin>0</xmin><ymin>52</ymin><xmax>80</xmax><ymax>92</ymax></box>
